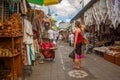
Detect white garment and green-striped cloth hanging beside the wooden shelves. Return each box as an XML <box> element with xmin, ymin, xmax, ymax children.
<box><xmin>23</xmin><ymin>19</ymin><xmax>36</xmax><ymax>65</ymax></box>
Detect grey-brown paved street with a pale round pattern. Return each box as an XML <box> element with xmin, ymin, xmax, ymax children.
<box><xmin>26</xmin><ymin>42</ymin><xmax>120</xmax><ymax>80</ymax></box>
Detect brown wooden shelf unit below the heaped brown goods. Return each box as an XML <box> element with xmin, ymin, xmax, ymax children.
<box><xmin>0</xmin><ymin>36</ymin><xmax>22</xmax><ymax>80</ymax></box>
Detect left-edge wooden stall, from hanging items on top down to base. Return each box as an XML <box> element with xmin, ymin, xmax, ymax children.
<box><xmin>0</xmin><ymin>0</ymin><xmax>23</xmax><ymax>80</ymax></box>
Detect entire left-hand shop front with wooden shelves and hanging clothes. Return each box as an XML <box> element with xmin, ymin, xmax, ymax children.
<box><xmin>0</xmin><ymin>0</ymin><xmax>47</xmax><ymax>80</ymax></box>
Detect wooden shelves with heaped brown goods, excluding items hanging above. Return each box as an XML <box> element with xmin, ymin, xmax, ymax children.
<box><xmin>0</xmin><ymin>13</ymin><xmax>23</xmax><ymax>80</ymax></box>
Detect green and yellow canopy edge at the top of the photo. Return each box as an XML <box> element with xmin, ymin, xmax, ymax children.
<box><xmin>28</xmin><ymin>0</ymin><xmax>62</xmax><ymax>6</ymax></box>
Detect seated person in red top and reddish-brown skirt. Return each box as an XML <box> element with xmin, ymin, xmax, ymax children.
<box><xmin>41</xmin><ymin>38</ymin><xmax>55</xmax><ymax>60</ymax></box>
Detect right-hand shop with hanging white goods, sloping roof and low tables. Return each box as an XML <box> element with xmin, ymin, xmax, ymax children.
<box><xmin>73</xmin><ymin>0</ymin><xmax>120</xmax><ymax>66</ymax></box>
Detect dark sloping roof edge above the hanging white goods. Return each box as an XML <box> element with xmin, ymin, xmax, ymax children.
<box><xmin>71</xmin><ymin>0</ymin><xmax>98</xmax><ymax>22</ymax></box>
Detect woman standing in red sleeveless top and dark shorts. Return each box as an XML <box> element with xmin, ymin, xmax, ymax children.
<box><xmin>73</xmin><ymin>21</ymin><xmax>83</xmax><ymax>69</ymax></box>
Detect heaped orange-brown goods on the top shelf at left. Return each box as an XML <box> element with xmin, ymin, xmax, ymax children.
<box><xmin>0</xmin><ymin>13</ymin><xmax>22</xmax><ymax>37</ymax></box>
